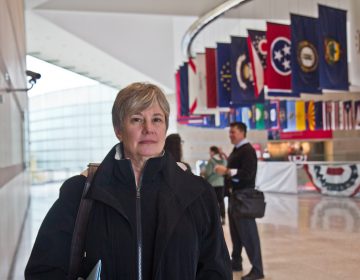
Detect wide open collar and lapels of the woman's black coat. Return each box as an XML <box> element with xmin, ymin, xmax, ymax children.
<box><xmin>88</xmin><ymin>145</ymin><xmax>204</xmax><ymax>274</ymax></box>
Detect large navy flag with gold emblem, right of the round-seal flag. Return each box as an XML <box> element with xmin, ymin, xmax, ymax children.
<box><xmin>319</xmin><ymin>5</ymin><xmax>349</xmax><ymax>90</ymax></box>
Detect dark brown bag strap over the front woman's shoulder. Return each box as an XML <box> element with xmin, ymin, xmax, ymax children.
<box><xmin>68</xmin><ymin>163</ymin><xmax>99</xmax><ymax>280</ymax></box>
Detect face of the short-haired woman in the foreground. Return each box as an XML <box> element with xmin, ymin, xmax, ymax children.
<box><xmin>116</xmin><ymin>102</ymin><xmax>166</xmax><ymax>160</ymax></box>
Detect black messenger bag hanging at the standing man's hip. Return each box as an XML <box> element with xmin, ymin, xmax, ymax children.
<box><xmin>230</xmin><ymin>188</ymin><xmax>266</xmax><ymax>218</ymax></box>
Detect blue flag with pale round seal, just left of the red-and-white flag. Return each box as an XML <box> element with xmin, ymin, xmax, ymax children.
<box><xmin>231</xmin><ymin>36</ymin><xmax>255</xmax><ymax>105</ymax></box>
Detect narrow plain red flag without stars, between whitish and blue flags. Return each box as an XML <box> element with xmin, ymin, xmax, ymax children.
<box><xmin>205</xmin><ymin>48</ymin><xmax>217</xmax><ymax>108</ymax></box>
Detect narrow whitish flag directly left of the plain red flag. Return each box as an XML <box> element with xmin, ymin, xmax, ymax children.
<box><xmin>195</xmin><ymin>53</ymin><xmax>207</xmax><ymax>113</ymax></box>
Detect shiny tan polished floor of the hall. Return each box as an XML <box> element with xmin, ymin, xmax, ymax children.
<box><xmin>9</xmin><ymin>184</ymin><xmax>360</xmax><ymax>280</ymax></box>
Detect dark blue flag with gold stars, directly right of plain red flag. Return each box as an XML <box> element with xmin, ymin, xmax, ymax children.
<box><xmin>216</xmin><ymin>43</ymin><xmax>231</xmax><ymax>107</ymax></box>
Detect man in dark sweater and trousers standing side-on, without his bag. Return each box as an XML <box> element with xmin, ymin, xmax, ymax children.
<box><xmin>215</xmin><ymin>122</ymin><xmax>264</xmax><ymax>280</ymax></box>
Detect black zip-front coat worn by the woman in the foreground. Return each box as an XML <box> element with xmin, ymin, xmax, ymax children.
<box><xmin>25</xmin><ymin>146</ymin><xmax>232</xmax><ymax>280</ymax></box>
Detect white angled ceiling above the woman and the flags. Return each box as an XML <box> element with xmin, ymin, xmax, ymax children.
<box><xmin>25</xmin><ymin>0</ymin><xmax>354</xmax><ymax>93</ymax></box>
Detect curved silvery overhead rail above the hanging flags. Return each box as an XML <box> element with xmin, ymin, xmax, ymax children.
<box><xmin>181</xmin><ymin>0</ymin><xmax>252</xmax><ymax>58</ymax></box>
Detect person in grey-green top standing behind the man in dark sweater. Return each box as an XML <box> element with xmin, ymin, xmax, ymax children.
<box><xmin>204</xmin><ymin>146</ymin><xmax>226</xmax><ymax>225</ymax></box>
